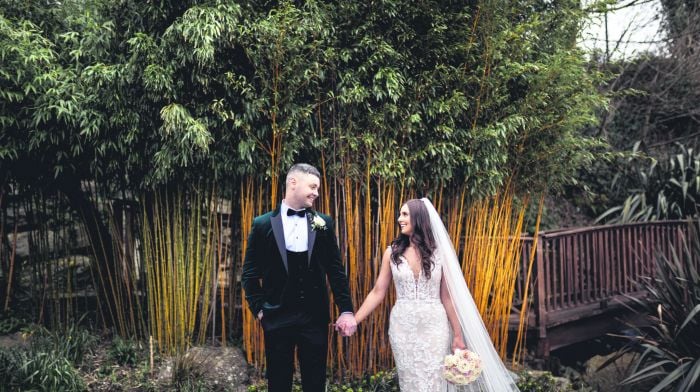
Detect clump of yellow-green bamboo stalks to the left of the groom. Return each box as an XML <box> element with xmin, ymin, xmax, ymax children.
<box><xmin>143</xmin><ymin>191</ymin><xmax>218</xmax><ymax>354</ymax></box>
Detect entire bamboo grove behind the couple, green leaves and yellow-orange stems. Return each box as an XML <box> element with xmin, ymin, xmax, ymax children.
<box><xmin>0</xmin><ymin>0</ymin><xmax>606</xmax><ymax>376</ymax></box>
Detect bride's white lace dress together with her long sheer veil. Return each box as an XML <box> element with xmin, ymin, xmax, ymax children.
<box><xmin>382</xmin><ymin>199</ymin><xmax>518</xmax><ymax>392</ymax></box>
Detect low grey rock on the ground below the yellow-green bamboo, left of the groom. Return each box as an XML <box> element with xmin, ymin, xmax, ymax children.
<box><xmin>157</xmin><ymin>347</ymin><xmax>249</xmax><ymax>391</ymax></box>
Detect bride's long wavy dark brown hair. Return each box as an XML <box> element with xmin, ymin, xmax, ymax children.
<box><xmin>391</xmin><ymin>199</ymin><xmax>436</xmax><ymax>279</ymax></box>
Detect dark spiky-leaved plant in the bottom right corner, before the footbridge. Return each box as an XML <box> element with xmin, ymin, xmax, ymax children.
<box><xmin>603</xmin><ymin>221</ymin><xmax>700</xmax><ymax>392</ymax></box>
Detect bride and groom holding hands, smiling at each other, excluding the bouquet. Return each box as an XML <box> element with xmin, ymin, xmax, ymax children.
<box><xmin>241</xmin><ymin>163</ymin><xmax>518</xmax><ymax>392</ymax></box>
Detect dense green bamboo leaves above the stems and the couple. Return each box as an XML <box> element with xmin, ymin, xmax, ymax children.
<box><xmin>0</xmin><ymin>0</ymin><xmax>603</xmax><ymax>195</ymax></box>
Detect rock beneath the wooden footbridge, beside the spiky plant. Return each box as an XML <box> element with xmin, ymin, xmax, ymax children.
<box><xmin>582</xmin><ymin>353</ymin><xmax>637</xmax><ymax>392</ymax></box>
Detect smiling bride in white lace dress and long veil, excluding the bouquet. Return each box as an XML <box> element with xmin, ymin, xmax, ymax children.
<box><xmin>355</xmin><ymin>198</ymin><xmax>518</xmax><ymax>392</ymax></box>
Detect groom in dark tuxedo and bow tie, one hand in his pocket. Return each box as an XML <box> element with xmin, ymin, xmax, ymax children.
<box><xmin>241</xmin><ymin>163</ymin><xmax>357</xmax><ymax>392</ymax></box>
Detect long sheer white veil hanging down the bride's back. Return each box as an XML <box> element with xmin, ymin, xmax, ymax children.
<box><xmin>421</xmin><ymin>198</ymin><xmax>518</xmax><ymax>392</ymax></box>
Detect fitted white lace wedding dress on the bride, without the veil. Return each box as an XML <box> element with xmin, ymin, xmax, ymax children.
<box><xmin>389</xmin><ymin>253</ymin><xmax>452</xmax><ymax>392</ymax></box>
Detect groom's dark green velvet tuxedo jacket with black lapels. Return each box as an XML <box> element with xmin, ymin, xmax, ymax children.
<box><xmin>241</xmin><ymin>207</ymin><xmax>353</xmax><ymax>323</ymax></box>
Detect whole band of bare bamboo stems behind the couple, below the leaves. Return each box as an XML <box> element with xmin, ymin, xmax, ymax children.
<box><xmin>1</xmin><ymin>176</ymin><xmax>536</xmax><ymax>377</ymax></box>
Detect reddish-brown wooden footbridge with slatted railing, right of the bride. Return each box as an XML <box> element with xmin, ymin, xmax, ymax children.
<box><xmin>510</xmin><ymin>221</ymin><xmax>688</xmax><ymax>358</ymax></box>
